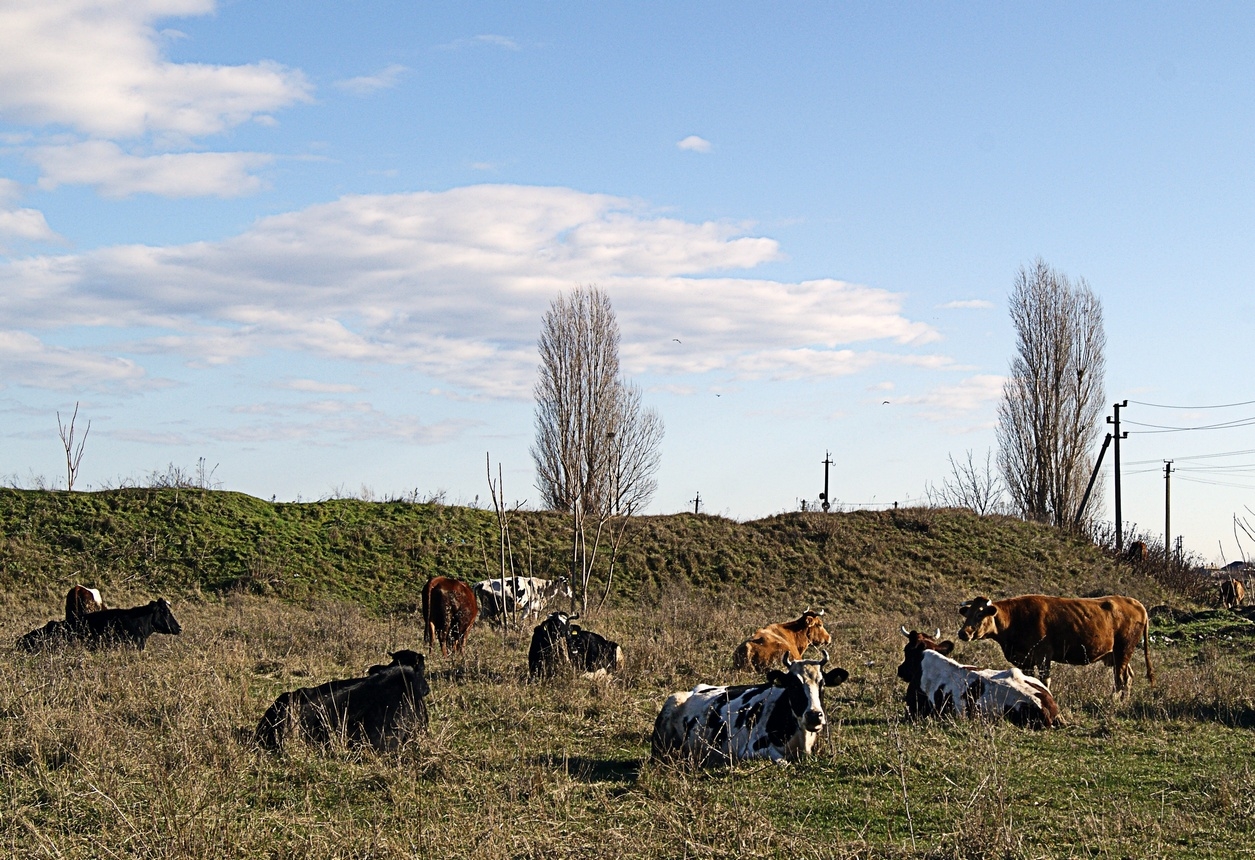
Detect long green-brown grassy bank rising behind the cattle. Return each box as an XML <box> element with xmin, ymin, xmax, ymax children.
<box><xmin>0</xmin><ymin>488</ymin><xmax>1162</xmax><ymax>611</ymax></box>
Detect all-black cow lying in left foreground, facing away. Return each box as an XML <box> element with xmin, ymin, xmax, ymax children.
<box><xmin>255</xmin><ymin>650</ymin><xmax>430</xmax><ymax>752</ymax></box>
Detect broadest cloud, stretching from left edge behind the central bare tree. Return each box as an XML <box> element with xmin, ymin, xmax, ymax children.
<box><xmin>0</xmin><ymin>185</ymin><xmax>954</xmax><ymax>397</ymax></box>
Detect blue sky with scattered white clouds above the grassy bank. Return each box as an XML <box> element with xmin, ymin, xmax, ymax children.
<box><xmin>0</xmin><ymin>0</ymin><xmax>1255</xmax><ymax>560</ymax></box>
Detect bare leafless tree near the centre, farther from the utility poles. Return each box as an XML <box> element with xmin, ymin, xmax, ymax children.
<box><xmin>532</xmin><ymin>286</ymin><xmax>663</xmax><ymax>609</ymax></box>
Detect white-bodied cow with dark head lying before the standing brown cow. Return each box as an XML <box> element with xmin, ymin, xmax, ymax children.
<box><xmin>897</xmin><ymin>626</ymin><xmax>1059</xmax><ymax>728</ymax></box>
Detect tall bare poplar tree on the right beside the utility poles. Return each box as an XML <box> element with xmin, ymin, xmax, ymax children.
<box><xmin>998</xmin><ymin>257</ymin><xmax>1107</xmax><ymax>526</ymax></box>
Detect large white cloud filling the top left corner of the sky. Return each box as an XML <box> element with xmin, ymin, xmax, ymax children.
<box><xmin>0</xmin><ymin>0</ymin><xmax>311</xmax><ymax>138</ymax></box>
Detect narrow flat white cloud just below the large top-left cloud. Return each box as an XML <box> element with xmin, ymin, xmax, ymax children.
<box><xmin>30</xmin><ymin>141</ymin><xmax>274</xmax><ymax>197</ymax></box>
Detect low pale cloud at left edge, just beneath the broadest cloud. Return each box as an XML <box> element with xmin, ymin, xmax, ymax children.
<box><xmin>0</xmin><ymin>330</ymin><xmax>149</xmax><ymax>390</ymax></box>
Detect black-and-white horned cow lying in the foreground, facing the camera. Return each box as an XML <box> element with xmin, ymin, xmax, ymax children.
<box><xmin>650</xmin><ymin>650</ymin><xmax>850</xmax><ymax>765</ymax></box>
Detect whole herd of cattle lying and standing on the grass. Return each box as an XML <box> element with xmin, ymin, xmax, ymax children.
<box><xmin>9</xmin><ymin>576</ymin><xmax>1219</xmax><ymax>763</ymax></box>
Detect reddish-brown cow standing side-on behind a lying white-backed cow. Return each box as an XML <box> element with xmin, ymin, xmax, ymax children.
<box><xmin>959</xmin><ymin>594</ymin><xmax>1155</xmax><ymax>694</ymax></box>
